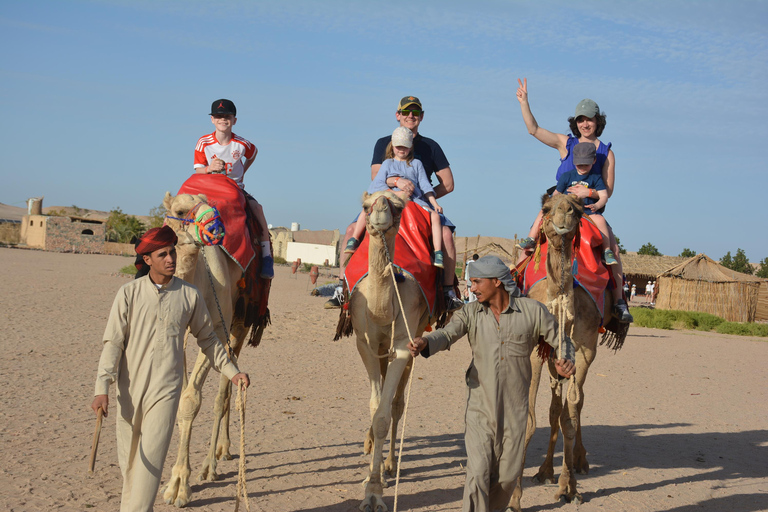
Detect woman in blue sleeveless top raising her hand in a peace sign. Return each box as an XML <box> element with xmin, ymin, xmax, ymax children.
<box><xmin>516</xmin><ymin>78</ymin><xmax>632</xmax><ymax>322</ymax></box>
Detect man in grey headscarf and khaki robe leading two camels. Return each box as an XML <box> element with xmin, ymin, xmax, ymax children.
<box><xmin>408</xmin><ymin>256</ymin><xmax>575</xmax><ymax>512</ymax></box>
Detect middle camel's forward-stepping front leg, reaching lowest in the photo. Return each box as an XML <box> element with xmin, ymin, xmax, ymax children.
<box><xmin>360</xmin><ymin>348</ymin><xmax>412</xmax><ymax>512</ymax></box>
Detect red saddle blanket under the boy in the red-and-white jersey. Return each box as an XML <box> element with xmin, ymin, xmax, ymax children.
<box><xmin>179</xmin><ymin>174</ymin><xmax>256</xmax><ymax>272</ymax></box>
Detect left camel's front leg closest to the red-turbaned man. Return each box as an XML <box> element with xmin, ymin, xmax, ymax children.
<box><xmin>163</xmin><ymin>352</ymin><xmax>211</xmax><ymax>507</ymax></box>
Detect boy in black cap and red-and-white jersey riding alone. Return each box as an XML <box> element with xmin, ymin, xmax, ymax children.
<box><xmin>195</xmin><ymin>99</ymin><xmax>275</xmax><ymax>279</ymax></box>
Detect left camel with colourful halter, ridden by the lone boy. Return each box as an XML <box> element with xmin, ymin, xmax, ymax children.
<box><xmin>163</xmin><ymin>192</ymin><xmax>266</xmax><ymax>507</ymax></box>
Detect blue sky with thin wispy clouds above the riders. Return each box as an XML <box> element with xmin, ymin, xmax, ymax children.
<box><xmin>0</xmin><ymin>0</ymin><xmax>768</xmax><ymax>263</ymax></box>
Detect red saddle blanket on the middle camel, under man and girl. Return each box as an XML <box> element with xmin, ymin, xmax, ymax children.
<box><xmin>344</xmin><ymin>202</ymin><xmax>437</xmax><ymax>316</ymax></box>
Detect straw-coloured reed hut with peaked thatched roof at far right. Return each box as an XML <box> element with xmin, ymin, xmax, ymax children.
<box><xmin>656</xmin><ymin>254</ymin><xmax>764</xmax><ymax>322</ymax></box>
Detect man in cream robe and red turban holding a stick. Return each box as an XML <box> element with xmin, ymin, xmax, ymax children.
<box><xmin>91</xmin><ymin>226</ymin><xmax>250</xmax><ymax>512</ymax></box>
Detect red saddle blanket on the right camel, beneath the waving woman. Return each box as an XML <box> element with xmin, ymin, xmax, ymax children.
<box><xmin>523</xmin><ymin>217</ymin><xmax>611</xmax><ymax>316</ymax></box>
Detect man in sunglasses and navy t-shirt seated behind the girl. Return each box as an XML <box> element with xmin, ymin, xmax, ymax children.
<box><xmin>325</xmin><ymin>96</ymin><xmax>463</xmax><ymax>310</ymax></box>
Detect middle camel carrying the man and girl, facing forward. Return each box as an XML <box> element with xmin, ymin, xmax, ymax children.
<box><xmin>349</xmin><ymin>190</ymin><xmax>429</xmax><ymax>512</ymax></box>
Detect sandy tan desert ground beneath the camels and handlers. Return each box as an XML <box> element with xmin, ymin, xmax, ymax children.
<box><xmin>0</xmin><ymin>248</ymin><xmax>768</xmax><ymax>512</ymax></box>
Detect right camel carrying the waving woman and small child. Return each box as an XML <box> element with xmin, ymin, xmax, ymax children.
<box><xmin>510</xmin><ymin>194</ymin><xmax>612</xmax><ymax>511</ymax></box>
